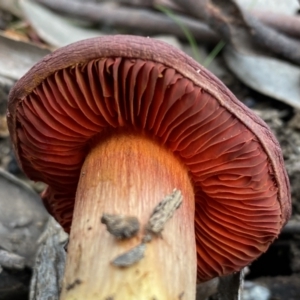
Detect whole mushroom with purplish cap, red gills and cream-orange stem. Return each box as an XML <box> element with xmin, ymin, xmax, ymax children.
<box><xmin>7</xmin><ymin>36</ymin><xmax>291</xmax><ymax>299</ymax></box>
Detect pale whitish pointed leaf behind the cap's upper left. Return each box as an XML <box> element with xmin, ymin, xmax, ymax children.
<box><xmin>20</xmin><ymin>0</ymin><xmax>103</xmax><ymax>47</ymax></box>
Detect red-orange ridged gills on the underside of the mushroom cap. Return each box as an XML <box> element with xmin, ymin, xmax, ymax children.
<box><xmin>17</xmin><ymin>58</ymin><xmax>281</xmax><ymax>281</ymax></box>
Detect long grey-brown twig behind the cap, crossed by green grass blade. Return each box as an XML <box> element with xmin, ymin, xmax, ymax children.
<box><xmin>36</xmin><ymin>0</ymin><xmax>219</xmax><ymax>42</ymax></box>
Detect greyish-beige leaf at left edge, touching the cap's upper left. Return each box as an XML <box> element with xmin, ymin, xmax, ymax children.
<box><xmin>0</xmin><ymin>32</ymin><xmax>50</xmax><ymax>80</ymax></box>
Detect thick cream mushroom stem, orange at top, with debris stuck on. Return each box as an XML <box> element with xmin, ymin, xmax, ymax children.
<box><xmin>60</xmin><ymin>134</ymin><xmax>197</xmax><ymax>300</ymax></box>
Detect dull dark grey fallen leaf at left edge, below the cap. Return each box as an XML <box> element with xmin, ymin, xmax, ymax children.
<box><xmin>0</xmin><ymin>169</ymin><xmax>49</xmax><ymax>266</ymax></box>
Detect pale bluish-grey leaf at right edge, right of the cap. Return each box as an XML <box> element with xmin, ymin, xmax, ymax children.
<box><xmin>223</xmin><ymin>47</ymin><xmax>300</xmax><ymax>109</ymax></box>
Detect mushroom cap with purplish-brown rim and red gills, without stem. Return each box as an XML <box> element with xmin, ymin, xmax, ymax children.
<box><xmin>7</xmin><ymin>36</ymin><xmax>291</xmax><ymax>280</ymax></box>
